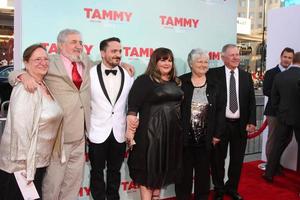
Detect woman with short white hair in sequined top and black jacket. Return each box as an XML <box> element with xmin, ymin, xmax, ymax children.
<box><xmin>175</xmin><ymin>49</ymin><xmax>225</xmax><ymax>200</ymax></box>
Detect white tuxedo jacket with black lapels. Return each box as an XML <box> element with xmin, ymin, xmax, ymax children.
<box><xmin>88</xmin><ymin>63</ymin><xmax>134</xmax><ymax>144</ymax></box>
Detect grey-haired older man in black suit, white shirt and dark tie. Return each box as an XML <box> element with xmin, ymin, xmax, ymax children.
<box><xmin>208</xmin><ymin>44</ymin><xmax>256</xmax><ymax>200</ymax></box>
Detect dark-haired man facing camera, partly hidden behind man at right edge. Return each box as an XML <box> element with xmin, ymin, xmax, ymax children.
<box><xmin>263</xmin><ymin>47</ymin><xmax>294</xmax><ymax>164</ymax></box>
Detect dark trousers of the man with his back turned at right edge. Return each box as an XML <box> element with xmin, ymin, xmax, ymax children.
<box><xmin>265</xmin><ymin>120</ymin><xmax>300</xmax><ymax>177</ymax></box>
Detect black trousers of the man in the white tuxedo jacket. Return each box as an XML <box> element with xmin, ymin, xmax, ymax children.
<box><xmin>89</xmin><ymin>132</ymin><xmax>126</xmax><ymax>200</ymax></box>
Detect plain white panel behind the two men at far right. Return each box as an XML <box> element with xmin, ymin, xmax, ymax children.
<box><xmin>262</xmin><ymin>6</ymin><xmax>300</xmax><ymax>170</ymax></box>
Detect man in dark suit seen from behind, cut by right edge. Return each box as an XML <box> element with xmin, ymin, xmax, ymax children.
<box><xmin>263</xmin><ymin>52</ymin><xmax>300</xmax><ymax>182</ymax></box>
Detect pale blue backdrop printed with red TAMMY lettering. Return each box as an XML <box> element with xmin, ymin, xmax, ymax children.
<box><xmin>14</xmin><ymin>0</ymin><xmax>237</xmax><ymax>200</ymax></box>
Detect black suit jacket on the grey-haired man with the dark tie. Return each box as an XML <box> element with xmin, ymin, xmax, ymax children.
<box><xmin>207</xmin><ymin>65</ymin><xmax>256</xmax><ymax>136</ymax></box>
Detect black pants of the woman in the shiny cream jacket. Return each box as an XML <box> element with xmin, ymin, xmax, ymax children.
<box><xmin>0</xmin><ymin>167</ymin><xmax>46</xmax><ymax>200</ymax></box>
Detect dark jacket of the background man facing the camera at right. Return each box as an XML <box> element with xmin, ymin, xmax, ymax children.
<box><xmin>263</xmin><ymin>65</ymin><xmax>281</xmax><ymax>116</ymax></box>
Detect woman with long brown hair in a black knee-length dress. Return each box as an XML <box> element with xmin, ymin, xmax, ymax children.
<box><xmin>126</xmin><ymin>48</ymin><xmax>183</xmax><ymax>200</ymax></box>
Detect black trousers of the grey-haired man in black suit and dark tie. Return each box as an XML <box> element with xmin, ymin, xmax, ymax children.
<box><xmin>211</xmin><ymin>120</ymin><xmax>247</xmax><ymax>193</ymax></box>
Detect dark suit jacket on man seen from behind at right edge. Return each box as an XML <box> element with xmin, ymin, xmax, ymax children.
<box><xmin>271</xmin><ymin>66</ymin><xmax>300</xmax><ymax>127</ymax></box>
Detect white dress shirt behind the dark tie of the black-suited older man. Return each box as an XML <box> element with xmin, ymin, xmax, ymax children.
<box><xmin>225</xmin><ymin>66</ymin><xmax>240</xmax><ymax>119</ymax></box>
